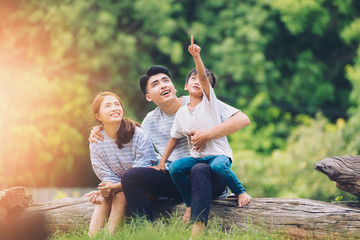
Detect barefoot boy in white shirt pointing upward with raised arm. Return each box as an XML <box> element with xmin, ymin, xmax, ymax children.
<box><xmin>156</xmin><ymin>36</ymin><xmax>251</xmax><ymax>229</ymax></box>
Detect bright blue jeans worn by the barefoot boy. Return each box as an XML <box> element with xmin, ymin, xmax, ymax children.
<box><xmin>169</xmin><ymin>155</ymin><xmax>245</xmax><ymax>207</ymax></box>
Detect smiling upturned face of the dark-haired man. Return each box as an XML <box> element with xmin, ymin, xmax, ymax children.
<box><xmin>145</xmin><ymin>73</ymin><xmax>176</xmax><ymax>105</ymax></box>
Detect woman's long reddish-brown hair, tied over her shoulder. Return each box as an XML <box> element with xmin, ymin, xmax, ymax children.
<box><xmin>92</xmin><ymin>92</ymin><xmax>140</xmax><ymax>149</ymax></box>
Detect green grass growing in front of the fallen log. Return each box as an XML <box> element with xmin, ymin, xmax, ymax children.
<box><xmin>50</xmin><ymin>216</ymin><xmax>289</xmax><ymax>240</ymax></box>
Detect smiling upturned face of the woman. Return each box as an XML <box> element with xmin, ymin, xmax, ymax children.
<box><xmin>96</xmin><ymin>95</ymin><xmax>124</xmax><ymax>125</ymax></box>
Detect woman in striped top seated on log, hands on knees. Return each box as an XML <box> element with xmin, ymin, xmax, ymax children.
<box><xmin>86</xmin><ymin>92</ymin><xmax>156</xmax><ymax>236</ymax></box>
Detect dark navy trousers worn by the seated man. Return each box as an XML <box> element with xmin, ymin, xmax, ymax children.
<box><xmin>121</xmin><ymin>163</ymin><xmax>226</xmax><ymax>224</ymax></box>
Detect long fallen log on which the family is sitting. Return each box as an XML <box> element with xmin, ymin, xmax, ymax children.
<box><xmin>2</xmin><ymin>188</ymin><xmax>360</xmax><ymax>239</ymax></box>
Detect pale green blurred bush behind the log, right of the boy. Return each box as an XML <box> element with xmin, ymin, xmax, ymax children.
<box><xmin>232</xmin><ymin>114</ymin><xmax>351</xmax><ymax>201</ymax></box>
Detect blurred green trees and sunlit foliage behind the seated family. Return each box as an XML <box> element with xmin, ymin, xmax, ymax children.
<box><xmin>0</xmin><ymin>0</ymin><xmax>360</xmax><ymax>201</ymax></box>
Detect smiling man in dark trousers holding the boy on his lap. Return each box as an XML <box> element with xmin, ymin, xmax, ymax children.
<box><xmin>122</xmin><ymin>66</ymin><xmax>250</xmax><ymax>237</ymax></box>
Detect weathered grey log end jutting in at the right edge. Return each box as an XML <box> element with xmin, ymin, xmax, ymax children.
<box><xmin>315</xmin><ymin>155</ymin><xmax>360</xmax><ymax>197</ymax></box>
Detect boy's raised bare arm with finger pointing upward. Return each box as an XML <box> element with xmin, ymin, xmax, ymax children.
<box><xmin>188</xmin><ymin>36</ymin><xmax>211</xmax><ymax>100</ymax></box>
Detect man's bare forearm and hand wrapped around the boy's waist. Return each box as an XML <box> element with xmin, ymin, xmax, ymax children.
<box><xmin>190</xmin><ymin>111</ymin><xmax>250</xmax><ymax>152</ymax></box>
